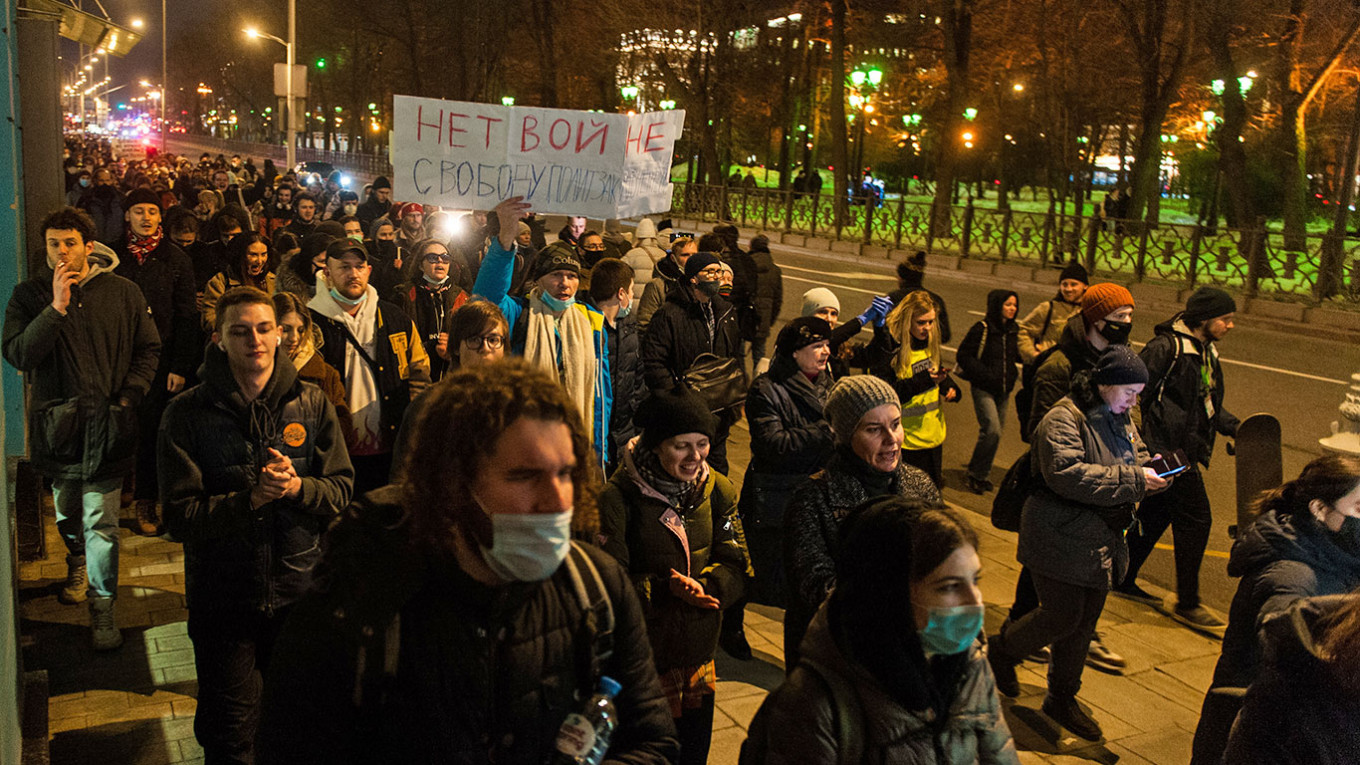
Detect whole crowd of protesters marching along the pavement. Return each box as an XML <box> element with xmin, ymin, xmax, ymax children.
<box><xmin>3</xmin><ymin>139</ymin><xmax>1360</xmax><ymax>764</ymax></box>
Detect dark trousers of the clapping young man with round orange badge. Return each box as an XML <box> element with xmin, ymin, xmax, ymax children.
<box><xmin>189</xmin><ymin>608</ymin><xmax>287</xmax><ymax>765</ymax></box>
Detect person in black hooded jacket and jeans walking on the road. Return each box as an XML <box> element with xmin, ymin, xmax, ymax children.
<box><xmin>955</xmin><ymin>290</ymin><xmax>1020</xmax><ymax>494</ymax></box>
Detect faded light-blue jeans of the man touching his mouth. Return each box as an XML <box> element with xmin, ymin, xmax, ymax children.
<box><xmin>52</xmin><ymin>478</ymin><xmax>122</xmax><ymax>598</ymax></box>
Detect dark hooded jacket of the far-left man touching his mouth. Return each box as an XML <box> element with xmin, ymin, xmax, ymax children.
<box><xmin>4</xmin><ymin>245</ymin><xmax>160</xmax><ymax>481</ymax></box>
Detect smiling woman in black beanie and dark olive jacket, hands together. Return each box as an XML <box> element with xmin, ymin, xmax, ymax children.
<box><xmin>601</xmin><ymin>386</ymin><xmax>751</xmax><ymax>765</ymax></box>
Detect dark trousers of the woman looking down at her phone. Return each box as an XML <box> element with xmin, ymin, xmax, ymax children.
<box><xmin>993</xmin><ymin>572</ymin><xmax>1108</xmax><ymax>698</ymax></box>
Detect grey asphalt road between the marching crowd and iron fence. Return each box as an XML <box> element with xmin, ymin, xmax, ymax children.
<box><xmin>733</xmin><ymin>239</ymin><xmax>1360</xmax><ymax>611</ymax></box>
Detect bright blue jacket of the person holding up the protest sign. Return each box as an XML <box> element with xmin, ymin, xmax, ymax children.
<box><xmin>472</xmin><ymin>237</ymin><xmax>613</xmax><ymax>468</ymax></box>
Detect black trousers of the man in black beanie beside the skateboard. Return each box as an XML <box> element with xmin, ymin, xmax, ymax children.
<box><xmin>1123</xmin><ymin>467</ymin><xmax>1213</xmax><ymax>608</ymax></box>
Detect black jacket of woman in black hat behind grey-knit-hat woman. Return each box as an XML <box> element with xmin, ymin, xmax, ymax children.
<box><xmin>747</xmin><ymin>355</ymin><xmax>835</xmax><ymax>473</ymax></box>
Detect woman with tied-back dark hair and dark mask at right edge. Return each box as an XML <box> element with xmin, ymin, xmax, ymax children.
<box><xmin>1191</xmin><ymin>455</ymin><xmax>1360</xmax><ymax>765</ymax></box>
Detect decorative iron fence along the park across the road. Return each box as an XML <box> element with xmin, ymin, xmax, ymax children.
<box><xmin>670</xmin><ymin>184</ymin><xmax>1360</xmax><ymax>304</ymax></box>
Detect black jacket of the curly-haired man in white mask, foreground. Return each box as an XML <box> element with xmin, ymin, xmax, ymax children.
<box><xmin>256</xmin><ymin>487</ymin><xmax>679</xmax><ymax>765</ymax></box>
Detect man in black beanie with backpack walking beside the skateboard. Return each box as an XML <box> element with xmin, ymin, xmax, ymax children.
<box><xmin>1115</xmin><ymin>287</ymin><xmax>1238</xmax><ymax>634</ymax></box>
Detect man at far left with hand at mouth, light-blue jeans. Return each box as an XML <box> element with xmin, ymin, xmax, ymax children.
<box><xmin>4</xmin><ymin>207</ymin><xmax>160</xmax><ymax>651</ymax></box>
